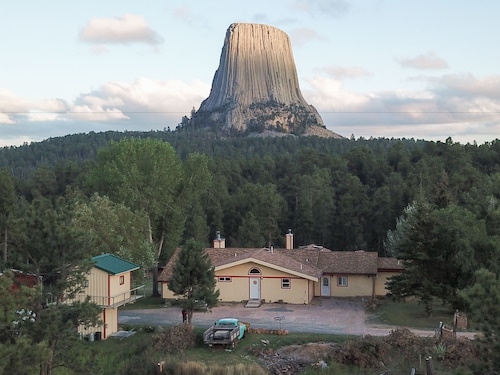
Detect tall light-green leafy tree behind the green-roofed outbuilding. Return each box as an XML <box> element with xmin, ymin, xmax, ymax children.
<box><xmin>89</xmin><ymin>138</ymin><xmax>210</xmax><ymax>296</ymax></box>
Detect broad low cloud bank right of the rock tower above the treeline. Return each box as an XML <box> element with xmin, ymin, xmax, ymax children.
<box><xmin>304</xmin><ymin>75</ymin><xmax>500</xmax><ymax>143</ymax></box>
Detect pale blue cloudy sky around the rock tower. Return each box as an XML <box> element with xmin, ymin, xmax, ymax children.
<box><xmin>0</xmin><ymin>0</ymin><xmax>500</xmax><ymax>147</ymax></box>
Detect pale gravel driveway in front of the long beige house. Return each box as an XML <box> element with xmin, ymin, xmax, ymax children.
<box><xmin>118</xmin><ymin>298</ymin><xmax>474</xmax><ymax>338</ymax></box>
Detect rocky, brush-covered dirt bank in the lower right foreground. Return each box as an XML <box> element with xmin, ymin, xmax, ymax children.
<box><xmin>250</xmin><ymin>328</ymin><xmax>478</xmax><ymax>375</ymax></box>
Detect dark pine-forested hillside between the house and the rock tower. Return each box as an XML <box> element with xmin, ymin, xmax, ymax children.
<box><xmin>0</xmin><ymin>131</ymin><xmax>500</xmax><ymax>254</ymax></box>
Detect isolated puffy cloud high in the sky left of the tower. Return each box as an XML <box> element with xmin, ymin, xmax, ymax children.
<box><xmin>80</xmin><ymin>14</ymin><xmax>163</xmax><ymax>45</ymax></box>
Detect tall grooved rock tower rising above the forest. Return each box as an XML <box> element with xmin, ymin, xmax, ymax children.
<box><xmin>191</xmin><ymin>23</ymin><xmax>342</xmax><ymax>135</ymax></box>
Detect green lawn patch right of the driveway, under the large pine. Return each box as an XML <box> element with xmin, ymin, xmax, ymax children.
<box><xmin>367</xmin><ymin>299</ymin><xmax>454</xmax><ymax>329</ymax></box>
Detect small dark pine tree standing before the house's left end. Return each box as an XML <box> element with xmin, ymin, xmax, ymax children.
<box><xmin>168</xmin><ymin>239</ymin><xmax>219</xmax><ymax>324</ymax></box>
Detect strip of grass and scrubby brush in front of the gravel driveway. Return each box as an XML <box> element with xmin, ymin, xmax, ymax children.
<box><xmin>44</xmin><ymin>326</ymin><xmax>475</xmax><ymax>375</ymax></box>
